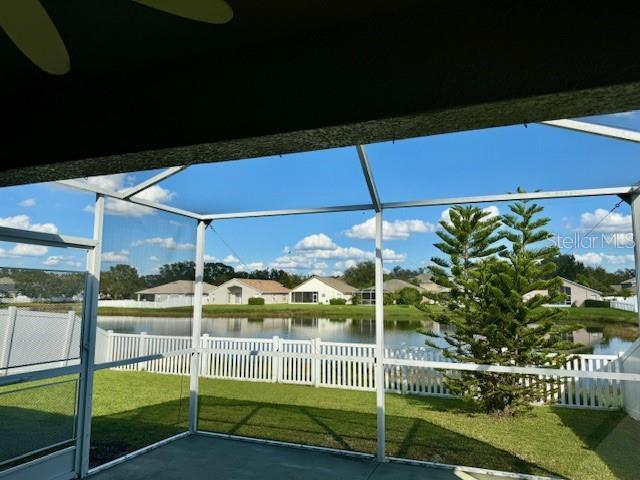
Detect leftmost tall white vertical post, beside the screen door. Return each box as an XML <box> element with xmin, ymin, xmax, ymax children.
<box><xmin>76</xmin><ymin>194</ymin><xmax>104</xmax><ymax>478</ymax></box>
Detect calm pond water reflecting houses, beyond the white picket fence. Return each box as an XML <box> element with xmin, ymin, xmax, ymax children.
<box><xmin>98</xmin><ymin>316</ymin><xmax>637</xmax><ymax>354</ymax></box>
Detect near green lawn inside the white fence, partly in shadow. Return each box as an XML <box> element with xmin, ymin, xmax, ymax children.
<box><xmin>5</xmin><ymin>371</ymin><xmax>640</xmax><ymax>479</ymax></box>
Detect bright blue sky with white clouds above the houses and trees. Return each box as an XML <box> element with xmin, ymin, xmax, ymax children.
<box><xmin>0</xmin><ymin>112</ymin><xmax>640</xmax><ymax>275</ymax></box>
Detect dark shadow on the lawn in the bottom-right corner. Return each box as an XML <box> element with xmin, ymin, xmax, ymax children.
<box><xmin>553</xmin><ymin>407</ymin><xmax>640</xmax><ymax>480</ymax></box>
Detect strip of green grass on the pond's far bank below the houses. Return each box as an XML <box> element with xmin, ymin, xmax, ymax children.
<box><xmin>98</xmin><ymin>304</ymin><xmax>436</xmax><ymax>321</ymax></box>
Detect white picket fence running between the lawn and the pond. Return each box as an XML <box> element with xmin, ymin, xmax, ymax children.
<box><xmin>102</xmin><ymin>332</ymin><xmax>622</xmax><ymax>409</ymax></box>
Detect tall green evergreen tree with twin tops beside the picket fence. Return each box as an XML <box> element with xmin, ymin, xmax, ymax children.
<box><xmin>427</xmin><ymin>197</ymin><xmax>575</xmax><ymax>414</ymax></box>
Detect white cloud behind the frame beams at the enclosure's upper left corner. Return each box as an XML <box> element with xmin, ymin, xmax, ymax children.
<box><xmin>84</xmin><ymin>173</ymin><xmax>176</xmax><ymax>217</ymax></box>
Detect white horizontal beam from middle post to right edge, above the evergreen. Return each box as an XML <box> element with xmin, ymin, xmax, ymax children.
<box><xmin>382</xmin><ymin>187</ymin><xmax>636</xmax><ymax>209</ymax></box>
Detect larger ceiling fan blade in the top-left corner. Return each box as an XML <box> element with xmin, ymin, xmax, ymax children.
<box><xmin>0</xmin><ymin>0</ymin><xmax>71</xmax><ymax>75</ymax></box>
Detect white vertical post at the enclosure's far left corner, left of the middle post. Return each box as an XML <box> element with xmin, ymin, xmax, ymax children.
<box><xmin>189</xmin><ymin>220</ymin><xmax>208</xmax><ymax>432</ymax></box>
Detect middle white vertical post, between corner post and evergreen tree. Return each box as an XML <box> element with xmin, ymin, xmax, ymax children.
<box><xmin>375</xmin><ymin>210</ymin><xmax>385</xmax><ymax>462</ymax></box>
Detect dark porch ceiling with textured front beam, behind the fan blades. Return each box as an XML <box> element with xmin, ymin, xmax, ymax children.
<box><xmin>0</xmin><ymin>0</ymin><xmax>640</xmax><ymax>185</ymax></box>
